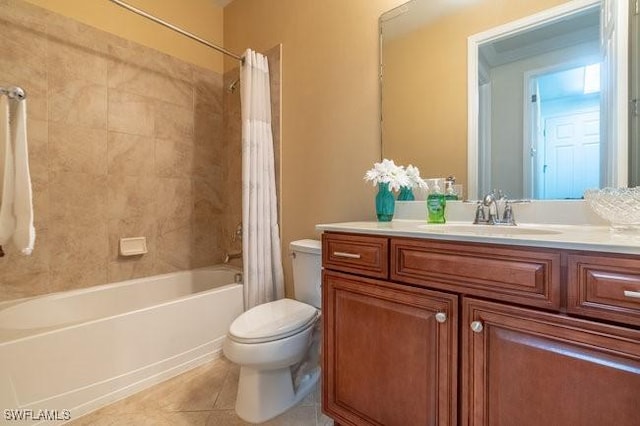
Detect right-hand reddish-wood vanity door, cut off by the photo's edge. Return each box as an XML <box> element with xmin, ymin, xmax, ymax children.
<box><xmin>461</xmin><ymin>298</ymin><xmax>640</xmax><ymax>426</ymax></box>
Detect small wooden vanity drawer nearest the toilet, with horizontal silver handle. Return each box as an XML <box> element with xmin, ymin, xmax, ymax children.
<box><xmin>322</xmin><ymin>232</ymin><xmax>389</xmax><ymax>279</ymax></box>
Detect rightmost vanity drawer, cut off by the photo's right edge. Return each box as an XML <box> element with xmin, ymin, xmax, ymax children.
<box><xmin>567</xmin><ymin>255</ymin><xmax>640</xmax><ymax>326</ymax></box>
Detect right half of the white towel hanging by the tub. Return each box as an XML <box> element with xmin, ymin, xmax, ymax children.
<box><xmin>11</xmin><ymin>99</ymin><xmax>36</xmax><ymax>255</ymax></box>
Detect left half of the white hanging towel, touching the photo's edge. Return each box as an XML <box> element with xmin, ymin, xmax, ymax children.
<box><xmin>0</xmin><ymin>95</ymin><xmax>16</xmax><ymax>245</ymax></box>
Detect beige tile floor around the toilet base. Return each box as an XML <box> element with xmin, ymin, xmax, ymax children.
<box><xmin>68</xmin><ymin>357</ymin><xmax>333</xmax><ymax>426</ymax></box>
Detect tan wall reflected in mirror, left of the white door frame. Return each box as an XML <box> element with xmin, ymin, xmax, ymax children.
<box><xmin>383</xmin><ymin>0</ymin><xmax>566</xmax><ymax>197</ymax></box>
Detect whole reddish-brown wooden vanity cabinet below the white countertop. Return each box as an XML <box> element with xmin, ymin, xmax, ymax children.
<box><xmin>322</xmin><ymin>232</ymin><xmax>640</xmax><ymax>426</ymax></box>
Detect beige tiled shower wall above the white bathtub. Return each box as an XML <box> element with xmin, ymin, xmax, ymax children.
<box><xmin>0</xmin><ymin>0</ymin><xmax>279</xmax><ymax>301</ymax></box>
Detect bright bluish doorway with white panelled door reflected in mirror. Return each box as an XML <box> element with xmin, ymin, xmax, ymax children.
<box><xmin>524</xmin><ymin>63</ymin><xmax>606</xmax><ymax>199</ymax></box>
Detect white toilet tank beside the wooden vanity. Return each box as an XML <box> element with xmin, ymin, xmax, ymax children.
<box><xmin>289</xmin><ymin>240</ymin><xmax>322</xmax><ymax>309</ymax></box>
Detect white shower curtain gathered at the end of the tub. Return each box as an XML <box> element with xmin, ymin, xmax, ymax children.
<box><xmin>240</xmin><ymin>49</ymin><xmax>284</xmax><ymax>309</ymax></box>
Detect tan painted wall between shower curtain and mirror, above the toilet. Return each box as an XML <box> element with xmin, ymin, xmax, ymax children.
<box><xmin>224</xmin><ymin>0</ymin><xmax>403</xmax><ymax>295</ymax></box>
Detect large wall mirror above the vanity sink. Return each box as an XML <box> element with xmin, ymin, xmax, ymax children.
<box><xmin>380</xmin><ymin>0</ymin><xmax>637</xmax><ymax>199</ymax></box>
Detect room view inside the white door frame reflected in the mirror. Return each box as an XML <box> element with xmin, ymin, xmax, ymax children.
<box><xmin>477</xmin><ymin>5</ymin><xmax>607</xmax><ymax>199</ymax></box>
